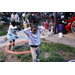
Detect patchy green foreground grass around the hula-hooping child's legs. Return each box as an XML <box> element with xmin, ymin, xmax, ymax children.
<box><xmin>12</xmin><ymin>40</ymin><xmax>75</xmax><ymax>62</ymax></box>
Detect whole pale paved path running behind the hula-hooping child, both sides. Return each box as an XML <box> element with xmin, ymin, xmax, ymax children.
<box><xmin>0</xmin><ymin>31</ymin><xmax>75</xmax><ymax>47</ymax></box>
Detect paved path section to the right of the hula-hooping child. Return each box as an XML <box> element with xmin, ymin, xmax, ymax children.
<box><xmin>45</xmin><ymin>33</ymin><xmax>75</xmax><ymax>47</ymax></box>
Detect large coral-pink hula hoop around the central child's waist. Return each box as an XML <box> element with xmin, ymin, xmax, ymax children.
<box><xmin>5</xmin><ymin>40</ymin><xmax>39</xmax><ymax>54</ymax></box>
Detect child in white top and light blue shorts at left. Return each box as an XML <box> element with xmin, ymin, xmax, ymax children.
<box><xmin>7</xmin><ymin>22</ymin><xmax>17</xmax><ymax>50</ymax></box>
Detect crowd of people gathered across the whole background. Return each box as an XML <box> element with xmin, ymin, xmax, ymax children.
<box><xmin>0</xmin><ymin>12</ymin><xmax>75</xmax><ymax>33</ymax></box>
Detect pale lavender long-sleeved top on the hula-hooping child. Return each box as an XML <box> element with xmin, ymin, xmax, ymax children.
<box><xmin>23</xmin><ymin>26</ymin><xmax>45</xmax><ymax>45</ymax></box>
